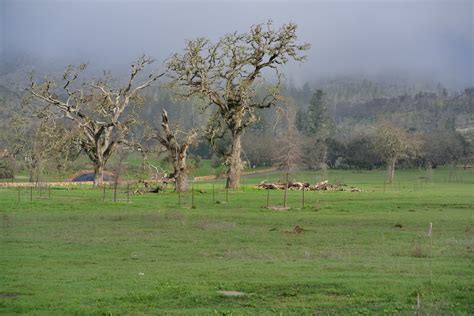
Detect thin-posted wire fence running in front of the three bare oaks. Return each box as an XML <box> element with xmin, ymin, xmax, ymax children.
<box><xmin>0</xmin><ymin>181</ymin><xmax>322</xmax><ymax>208</ymax></box>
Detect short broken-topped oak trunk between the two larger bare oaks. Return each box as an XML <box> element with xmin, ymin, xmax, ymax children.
<box><xmin>151</xmin><ymin>110</ymin><xmax>197</xmax><ymax>192</ymax></box>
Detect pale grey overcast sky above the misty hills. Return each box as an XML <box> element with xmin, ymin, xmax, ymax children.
<box><xmin>0</xmin><ymin>0</ymin><xmax>474</xmax><ymax>88</ymax></box>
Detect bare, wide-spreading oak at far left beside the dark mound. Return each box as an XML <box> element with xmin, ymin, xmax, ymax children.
<box><xmin>30</xmin><ymin>56</ymin><xmax>164</xmax><ymax>185</ymax></box>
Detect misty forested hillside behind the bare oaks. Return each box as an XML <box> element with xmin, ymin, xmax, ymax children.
<box><xmin>0</xmin><ymin>58</ymin><xmax>474</xmax><ymax>181</ymax></box>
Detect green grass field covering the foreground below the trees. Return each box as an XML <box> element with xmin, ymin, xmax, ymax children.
<box><xmin>0</xmin><ymin>169</ymin><xmax>474</xmax><ymax>315</ymax></box>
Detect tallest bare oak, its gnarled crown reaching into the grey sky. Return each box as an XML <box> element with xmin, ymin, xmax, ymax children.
<box><xmin>168</xmin><ymin>21</ymin><xmax>309</xmax><ymax>188</ymax></box>
